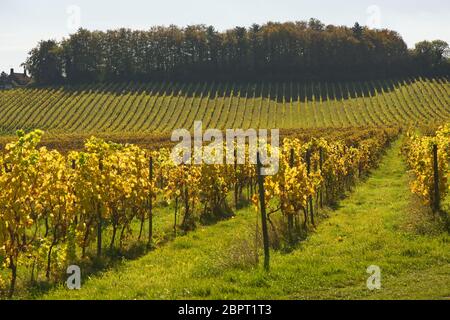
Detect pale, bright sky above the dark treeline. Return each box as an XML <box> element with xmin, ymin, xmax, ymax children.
<box><xmin>0</xmin><ymin>0</ymin><xmax>450</xmax><ymax>72</ymax></box>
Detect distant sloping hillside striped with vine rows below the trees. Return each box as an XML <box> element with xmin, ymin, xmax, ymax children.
<box><xmin>0</xmin><ymin>78</ymin><xmax>450</xmax><ymax>135</ymax></box>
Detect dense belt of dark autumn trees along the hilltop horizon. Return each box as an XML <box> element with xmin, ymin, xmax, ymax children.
<box><xmin>25</xmin><ymin>19</ymin><xmax>448</xmax><ymax>84</ymax></box>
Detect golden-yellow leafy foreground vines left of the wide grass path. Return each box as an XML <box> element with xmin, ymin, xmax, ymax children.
<box><xmin>0</xmin><ymin>128</ymin><xmax>398</xmax><ymax>296</ymax></box>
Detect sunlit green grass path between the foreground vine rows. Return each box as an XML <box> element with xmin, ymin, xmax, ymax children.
<box><xmin>45</xmin><ymin>142</ymin><xmax>450</xmax><ymax>299</ymax></box>
